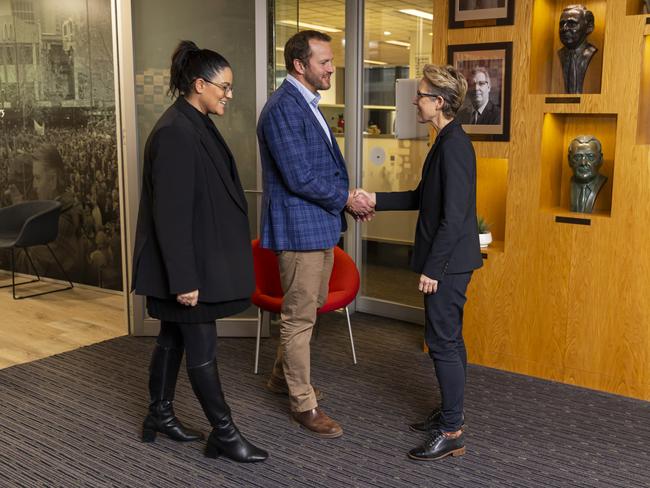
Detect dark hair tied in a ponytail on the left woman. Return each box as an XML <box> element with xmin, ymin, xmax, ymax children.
<box><xmin>169</xmin><ymin>41</ymin><xmax>230</xmax><ymax>97</ymax></box>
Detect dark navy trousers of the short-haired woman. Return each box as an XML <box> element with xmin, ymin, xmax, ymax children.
<box><xmin>424</xmin><ymin>272</ymin><xmax>472</xmax><ymax>432</ymax></box>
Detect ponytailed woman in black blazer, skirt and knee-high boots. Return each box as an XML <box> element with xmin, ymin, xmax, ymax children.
<box><xmin>133</xmin><ymin>41</ymin><xmax>268</xmax><ymax>462</ymax></box>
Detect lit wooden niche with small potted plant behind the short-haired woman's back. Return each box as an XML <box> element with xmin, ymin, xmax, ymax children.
<box><xmin>476</xmin><ymin>157</ymin><xmax>508</xmax><ymax>257</ymax></box>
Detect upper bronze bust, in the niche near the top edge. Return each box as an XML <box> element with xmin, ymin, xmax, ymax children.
<box><xmin>557</xmin><ymin>4</ymin><xmax>598</xmax><ymax>93</ymax></box>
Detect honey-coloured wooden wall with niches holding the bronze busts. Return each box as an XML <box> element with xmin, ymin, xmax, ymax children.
<box><xmin>433</xmin><ymin>0</ymin><xmax>650</xmax><ymax>400</ymax></box>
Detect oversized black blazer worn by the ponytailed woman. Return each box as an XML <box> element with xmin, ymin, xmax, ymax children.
<box><xmin>133</xmin><ymin>97</ymin><xmax>255</xmax><ymax>302</ymax></box>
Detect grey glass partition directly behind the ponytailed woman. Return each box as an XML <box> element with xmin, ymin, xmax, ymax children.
<box><xmin>132</xmin><ymin>0</ymin><xmax>258</xmax><ymax>317</ymax></box>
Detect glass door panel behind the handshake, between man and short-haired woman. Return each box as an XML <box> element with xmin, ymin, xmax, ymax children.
<box><xmin>357</xmin><ymin>0</ymin><xmax>433</xmax><ymax>322</ymax></box>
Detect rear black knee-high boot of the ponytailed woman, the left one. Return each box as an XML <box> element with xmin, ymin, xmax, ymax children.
<box><xmin>142</xmin><ymin>344</ymin><xmax>203</xmax><ymax>442</ymax></box>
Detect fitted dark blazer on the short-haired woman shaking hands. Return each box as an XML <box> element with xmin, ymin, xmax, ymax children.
<box><xmin>376</xmin><ymin>120</ymin><xmax>483</xmax><ymax>281</ymax></box>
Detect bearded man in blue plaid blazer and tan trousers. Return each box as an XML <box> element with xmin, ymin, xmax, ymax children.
<box><xmin>257</xmin><ymin>31</ymin><xmax>370</xmax><ymax>438</ymax></box>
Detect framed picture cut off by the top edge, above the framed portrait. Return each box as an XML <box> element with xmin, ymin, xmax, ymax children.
<box><xmin>449</xmin><ymin>0</ymin><xmax>515</xmax><ymax>29</ymax></box>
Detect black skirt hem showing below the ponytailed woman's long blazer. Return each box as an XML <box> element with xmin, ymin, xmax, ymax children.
<box><xmin>147</xmin><ymin>297</ymin><xmax>251</xmax><ymax>324</ymax></box>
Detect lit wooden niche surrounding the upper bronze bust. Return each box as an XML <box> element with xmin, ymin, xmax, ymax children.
<box><xmin>530</xmin><ymin>0</ymin><xmax>607</xmax><ymax>95</ymax></box>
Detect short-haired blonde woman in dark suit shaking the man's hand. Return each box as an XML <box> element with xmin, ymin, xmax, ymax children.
<box><xmin>360</xmin><ymin>65</ymin><xmax>482</xmax><ymax>460</ymax></box>
